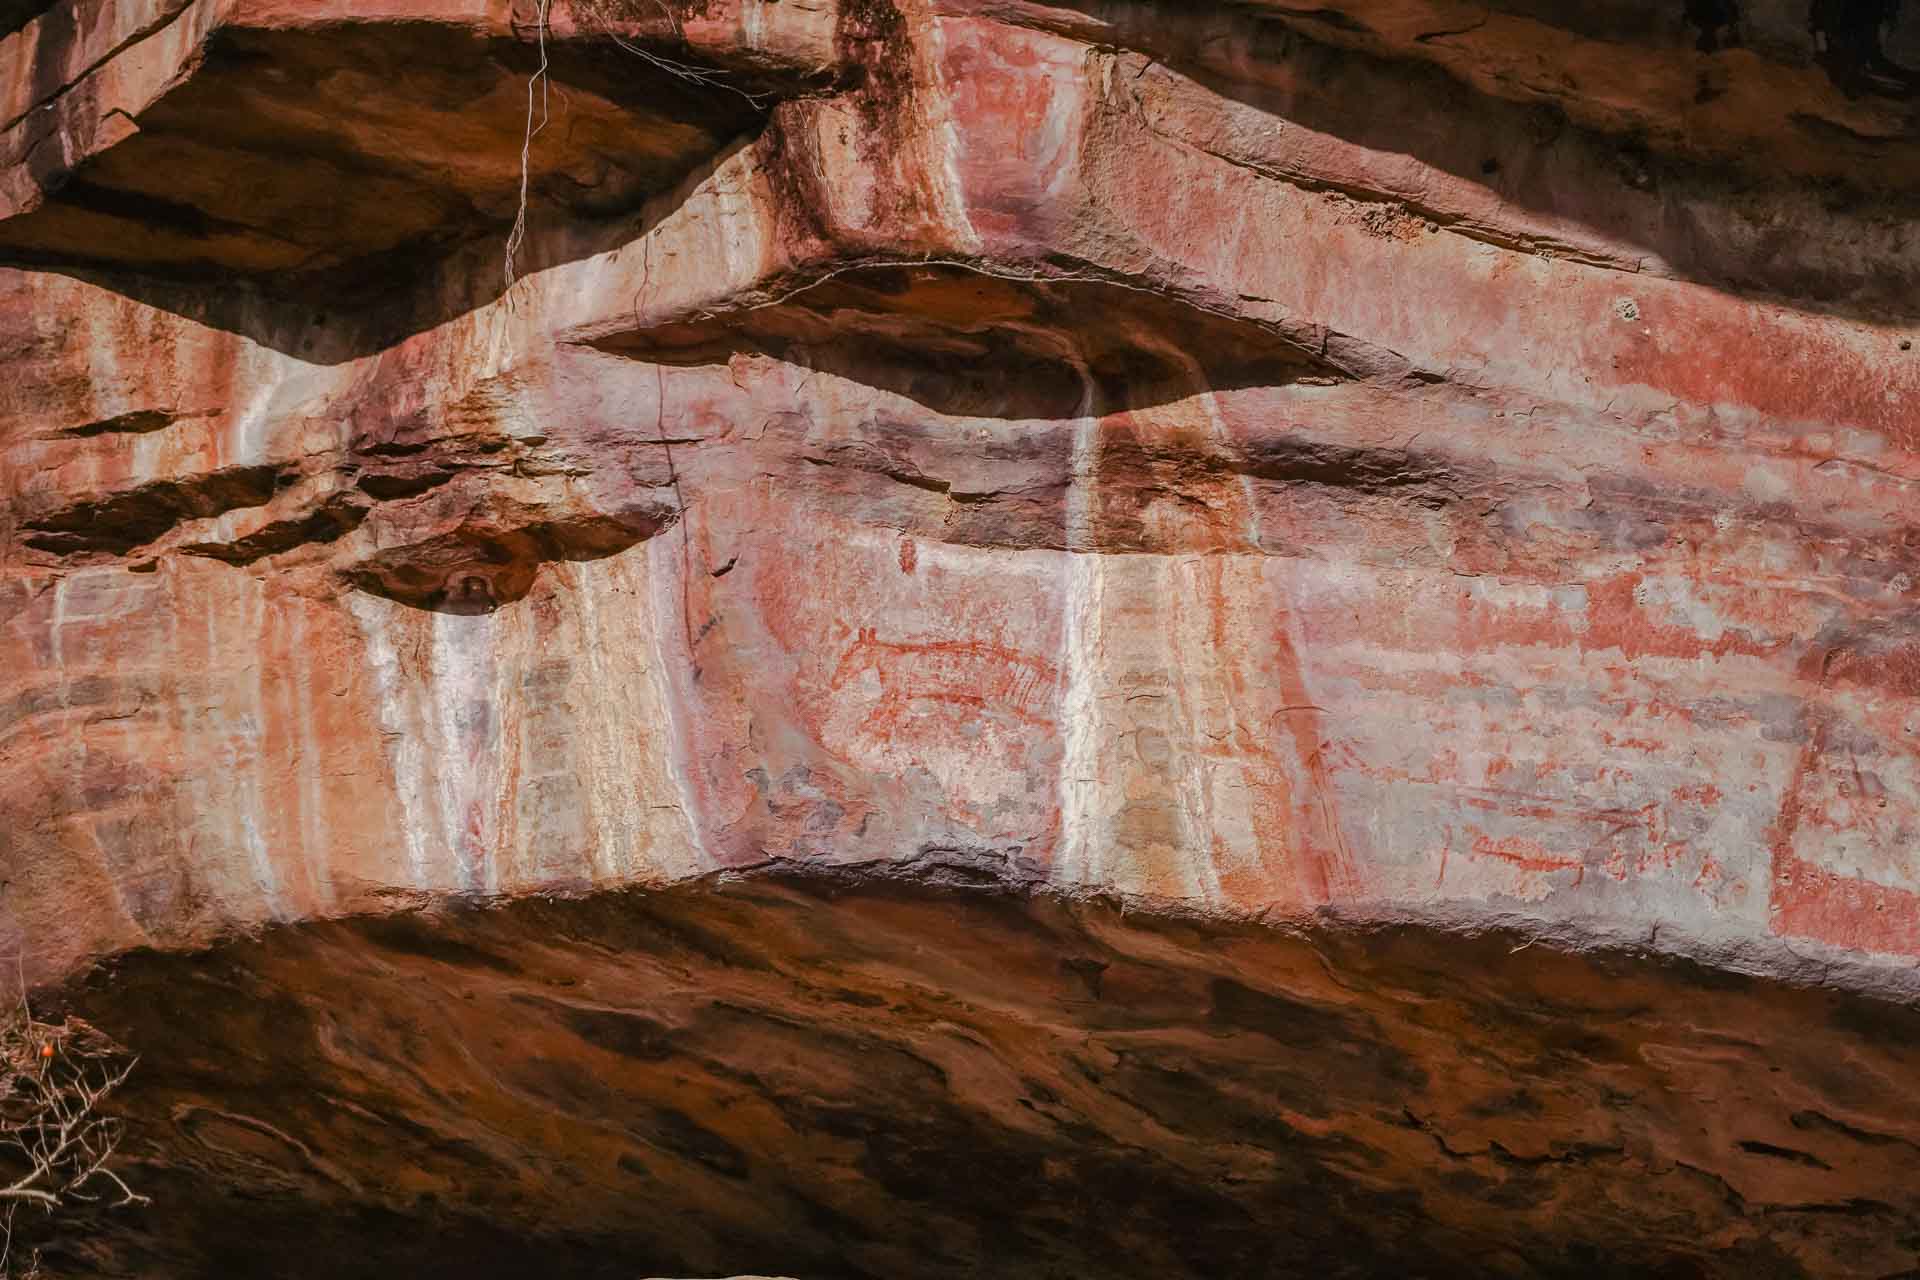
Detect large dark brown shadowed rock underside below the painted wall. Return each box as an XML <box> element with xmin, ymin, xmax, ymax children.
<box><xmin>37</xmin><ymin>875</ymin><xmax>1920</xmax><ymax>1280</ymax></box>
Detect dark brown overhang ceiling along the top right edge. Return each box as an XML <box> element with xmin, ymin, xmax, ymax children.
<box><xmin>990</xmin><ymin>0</ymin><xmax>1920</xmax><ymax>196</ymax></box>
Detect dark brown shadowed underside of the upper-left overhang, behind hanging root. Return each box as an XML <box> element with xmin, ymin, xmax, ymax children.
<box><xmin>0</xmin><ymin>21</ymin><xmax>799</xmax><ymax>333</ymax></box>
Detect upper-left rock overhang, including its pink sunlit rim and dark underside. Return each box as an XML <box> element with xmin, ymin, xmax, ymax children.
<box><xmin>0</xmin><ymin>0</ymin><xmax>837</xmax><ymax>313</ymax></box>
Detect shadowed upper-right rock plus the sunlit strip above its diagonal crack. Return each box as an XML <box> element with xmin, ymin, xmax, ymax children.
<box><xmin>1018</xmin><ymin>0</ymin><xmax>1920</xmax><ymax>317</ymax></box>
